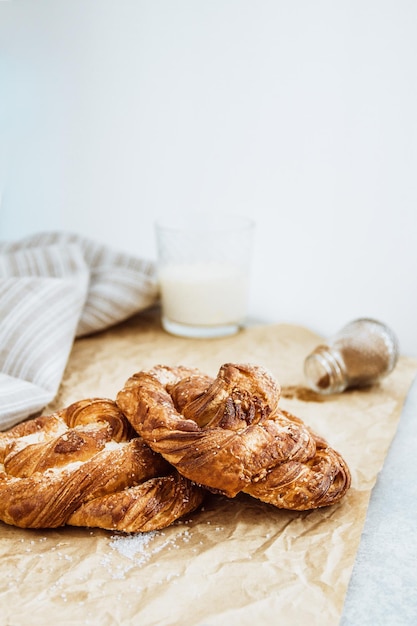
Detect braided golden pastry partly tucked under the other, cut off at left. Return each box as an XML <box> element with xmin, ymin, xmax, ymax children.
<box><xmin>0</xmin><ymin>398</ymin><xmax>203</xmax><ymax>532</ymax></box>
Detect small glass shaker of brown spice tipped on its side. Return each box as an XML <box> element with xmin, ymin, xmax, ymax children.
<box><xmin>304</xmin><ymin>318</ymin><xmax>399</xmax><ymax>394</ymax></box>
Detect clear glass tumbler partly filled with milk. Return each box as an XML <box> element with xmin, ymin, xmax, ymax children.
<box><xmin>156</xmin><ymin>215</ymin><xmax>254</xmax><ymax>338</ymax></box>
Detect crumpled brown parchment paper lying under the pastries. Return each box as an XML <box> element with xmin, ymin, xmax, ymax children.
<box><xmin>0</xmin><ymin>311</ymin><xmax>417</xmax><ymax>626</ymax></box>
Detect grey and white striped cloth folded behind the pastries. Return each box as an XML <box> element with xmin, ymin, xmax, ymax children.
<box><xmin>0</xmin><ymin>232</ymin><xmax>158</xmax><ymax>430</ymax></box>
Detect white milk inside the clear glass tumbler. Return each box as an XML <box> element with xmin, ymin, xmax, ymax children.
<box><xmin>159</xmin><ymin>262</ymin><xmax>248</xmax><ymax>326</ymax></box>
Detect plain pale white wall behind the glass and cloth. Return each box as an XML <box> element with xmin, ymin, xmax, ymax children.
<box><xmin>0</xmin><ymin>0</ymin><xmax>417</xmax><ymax>356</ymax></box>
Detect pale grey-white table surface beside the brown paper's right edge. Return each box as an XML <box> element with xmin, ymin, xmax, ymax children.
<box><xmin>340</xmin><ymin>372</ymin><xmax>417</xmax><ymax>626</ymax></box>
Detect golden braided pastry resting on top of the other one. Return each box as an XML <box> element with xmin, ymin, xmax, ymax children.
<box><xmin>116</xmin><ymin>363</ymin><xmax>350</xmax><ymax>510</ymax></box>
